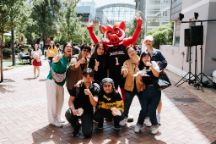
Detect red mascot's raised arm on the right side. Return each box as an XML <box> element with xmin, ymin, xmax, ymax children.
<box><xmin>123</xmin><ymin>18</ymin><xmax>142</xmax><ymax>47</ymax></box>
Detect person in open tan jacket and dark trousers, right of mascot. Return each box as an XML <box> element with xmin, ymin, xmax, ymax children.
<box><xmin>120</xmin><ymin>46</ymin><xmax>144</xmax><ymax>126</ymax></box>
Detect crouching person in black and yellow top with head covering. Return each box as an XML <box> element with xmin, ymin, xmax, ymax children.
<box><xmin>95</xmin><ymin>78</ymin><xmax>124</xmax><ymax>131</ymax></box>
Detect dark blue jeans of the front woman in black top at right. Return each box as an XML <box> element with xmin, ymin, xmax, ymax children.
<box><xmin>137</xmin><ymin>85</ymin><xmax>161</xmax><ymax>125</ymax></box>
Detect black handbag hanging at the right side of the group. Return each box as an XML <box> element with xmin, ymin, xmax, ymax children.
<box><xmin>157</xmin><ymin>71</ymin><xmax>171</xmax><ymax>90</ymax></box>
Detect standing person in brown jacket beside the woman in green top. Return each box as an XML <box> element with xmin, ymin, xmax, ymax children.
<box><xmin>66</xmin><ymin>45</ymin><xmax>91</xmax><ymax>95</ymax></box>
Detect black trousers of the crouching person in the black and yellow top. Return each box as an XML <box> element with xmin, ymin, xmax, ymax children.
<box><xmin>94</xmin><ymin>109</ymin><xmax>122</xmax><ymax>126</ymax></box>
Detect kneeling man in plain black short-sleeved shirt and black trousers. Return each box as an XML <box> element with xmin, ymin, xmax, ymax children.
<box><xmin>65</xmin><ymin>68</ymin><xmax>100</xmax><ymax>138</ymax></box>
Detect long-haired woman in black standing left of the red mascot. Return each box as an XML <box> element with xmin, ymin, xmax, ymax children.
<box><xmin>89</xmin><ymin>43</ymin><xmax>107</xmax><ymax>84</ymax></box>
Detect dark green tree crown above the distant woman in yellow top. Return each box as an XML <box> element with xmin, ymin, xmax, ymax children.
<box><xmin>25</xmin><ymin>0</ymin><xmax>61</xmax><ymax>43</ymax></box>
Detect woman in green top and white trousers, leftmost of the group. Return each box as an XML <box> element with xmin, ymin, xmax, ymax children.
<box><xmin>46</xmin><ymin>43</ymin><xmax>72</xmax><ymax>127</ymax></box>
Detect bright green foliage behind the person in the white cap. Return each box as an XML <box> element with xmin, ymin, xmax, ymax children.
<box><xmin>148</xmin><ymin>22</ymin><xmax>173</xmax><ymax>48</ymax></box>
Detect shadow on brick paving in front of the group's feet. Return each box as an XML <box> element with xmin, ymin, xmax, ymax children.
<box><xmin>32</xmin><ymin>124</ymin><xmax>166</xmax><ymax>144</ymax></box>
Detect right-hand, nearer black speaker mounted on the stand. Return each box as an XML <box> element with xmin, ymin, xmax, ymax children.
<box><xmin>190</xmin><ymin>25</ymin><xmax>203</xmax><ymax>46</ymax></box>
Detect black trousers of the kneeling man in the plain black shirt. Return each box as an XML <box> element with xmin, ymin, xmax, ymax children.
<box><xmin>65</xmin><ymin>109</ymin><xmax>93</xmax><ymax>137</ymax></box>
